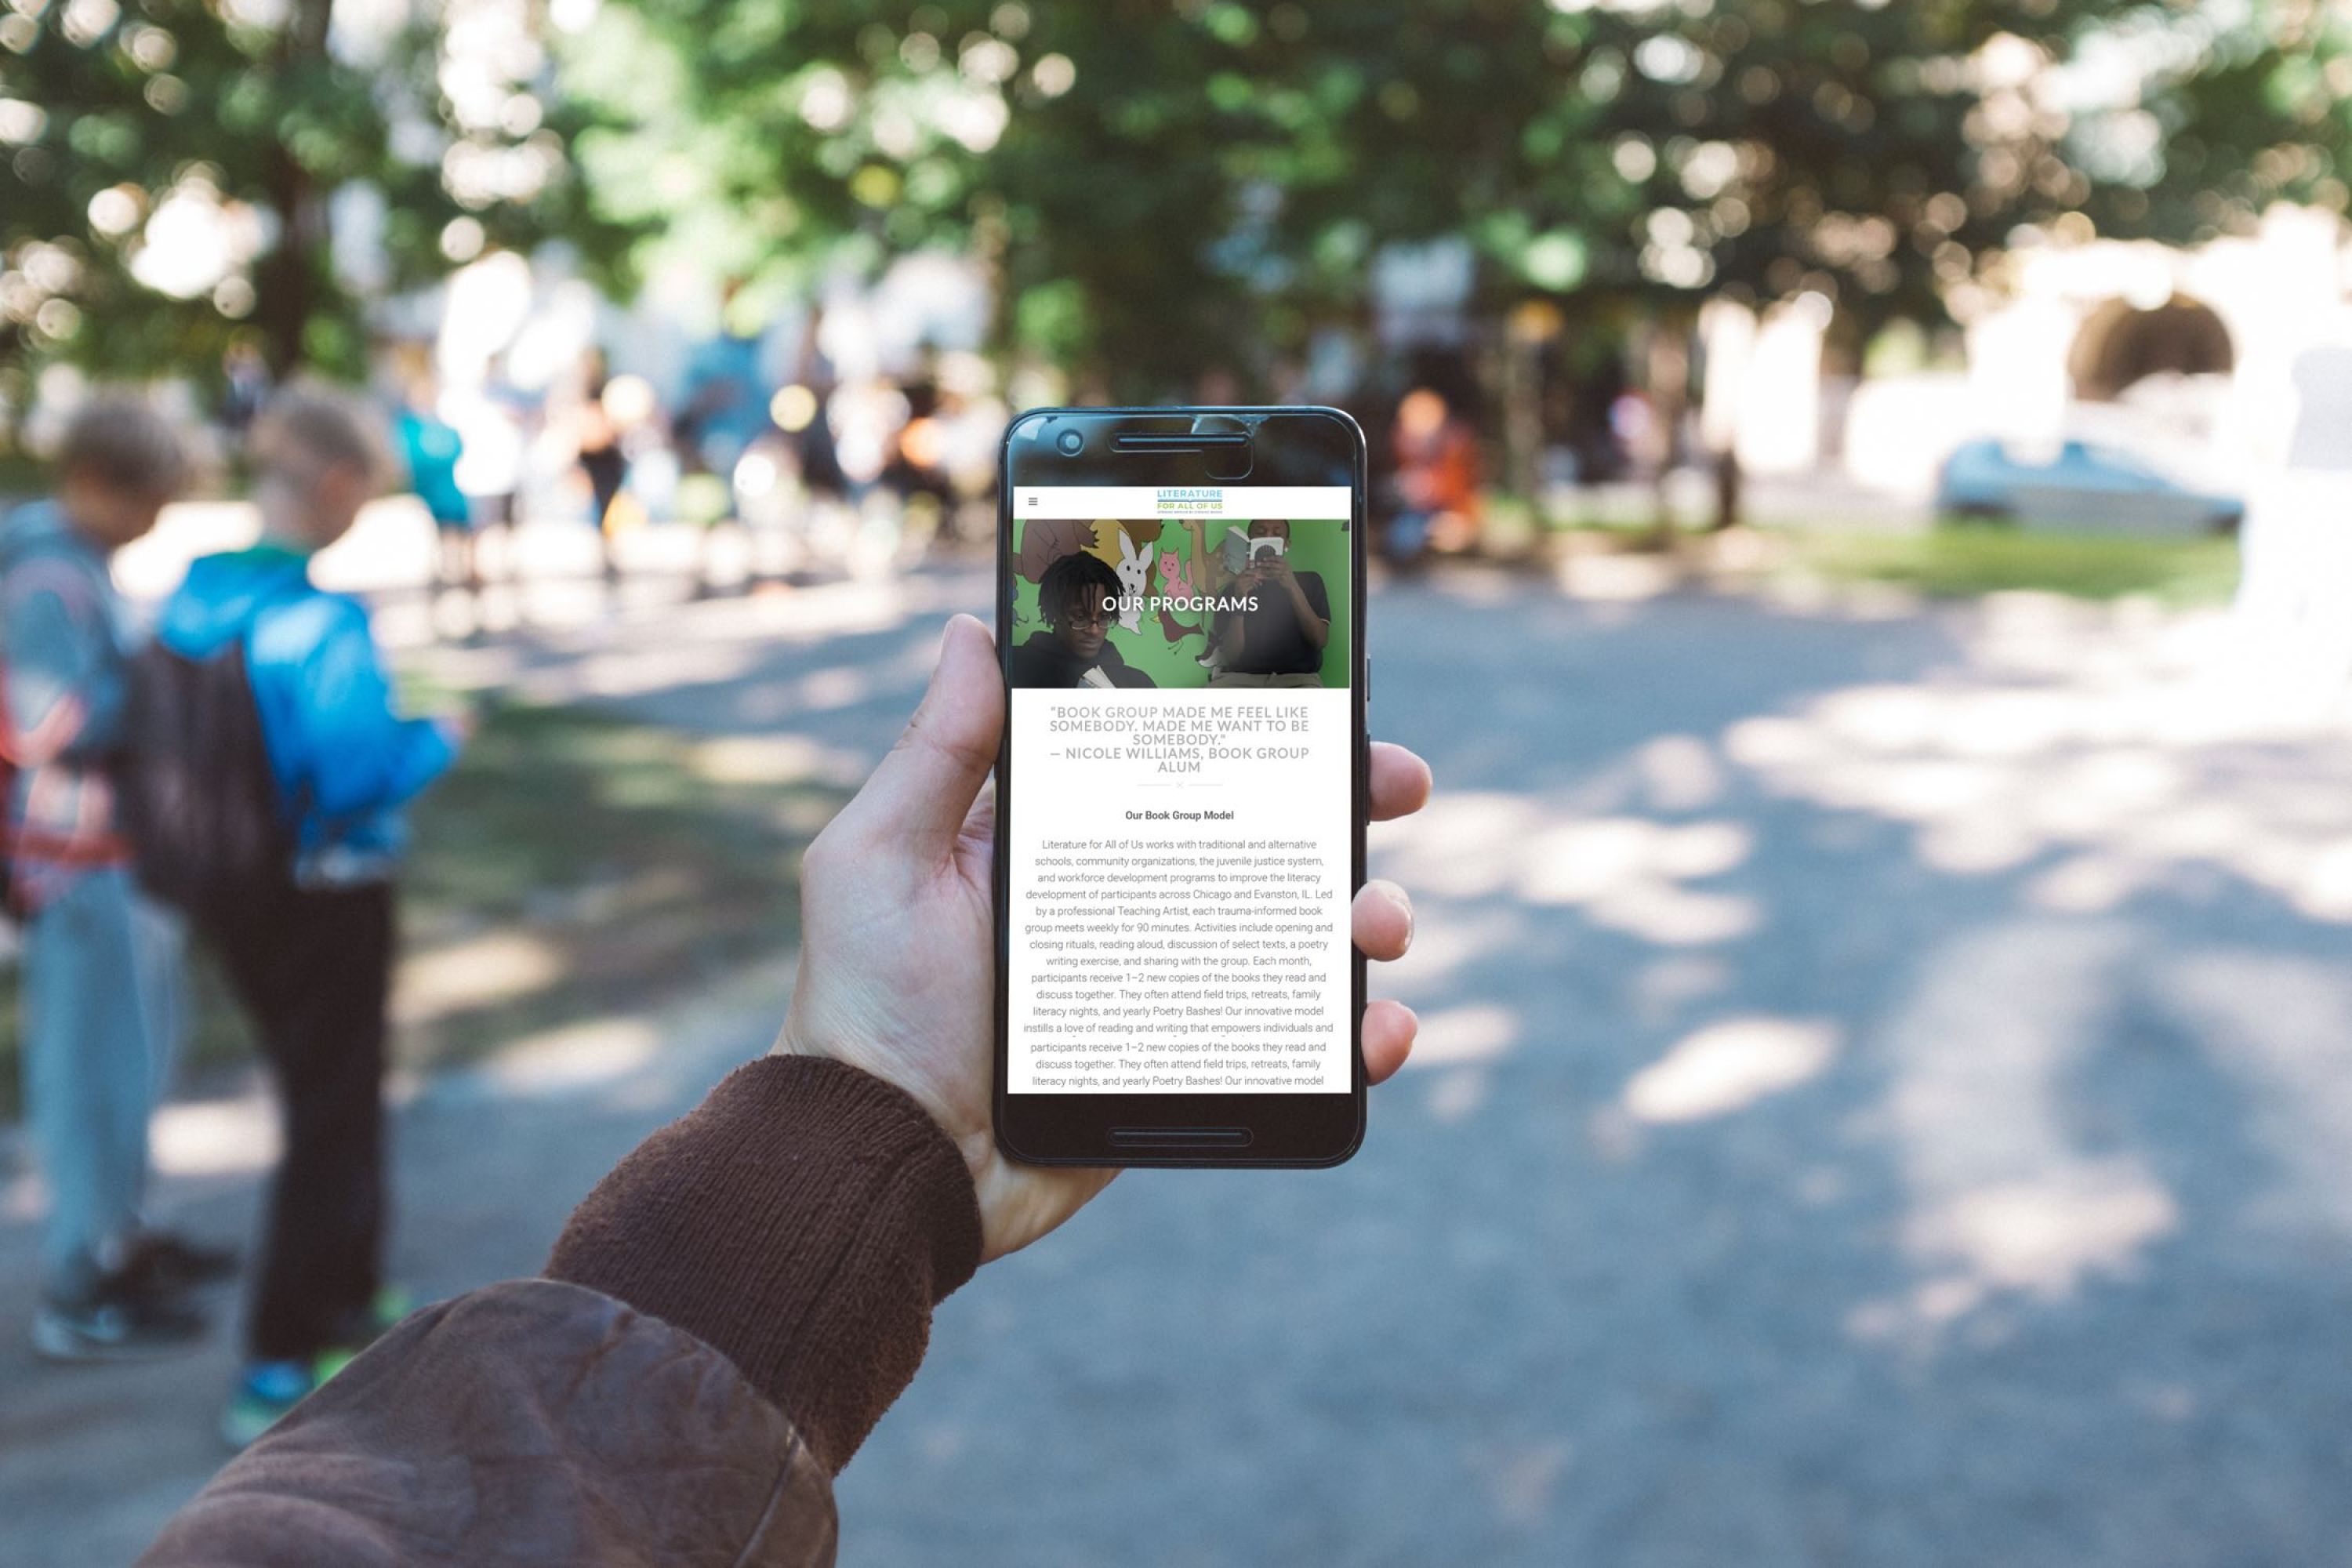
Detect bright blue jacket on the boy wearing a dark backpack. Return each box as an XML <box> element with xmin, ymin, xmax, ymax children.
<box><xmin>155</xmin><ymin>543</ymin><xmax>456</xmax><ymax>881</ymax></box>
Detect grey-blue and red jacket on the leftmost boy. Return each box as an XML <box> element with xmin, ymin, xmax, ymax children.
<box><xmin>0</xmin><ymin>501</ymin><xmax>136</xmax><ymax>907</ymax></box>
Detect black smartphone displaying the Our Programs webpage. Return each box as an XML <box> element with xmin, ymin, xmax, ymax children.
<box><xmin>995</xmin><ymin>409</ymin><xmax>1367</xmax><ymax>1166</ymax></box>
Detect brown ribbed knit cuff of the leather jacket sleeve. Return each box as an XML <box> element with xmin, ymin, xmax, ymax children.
<box><xmin>546</xmin><ymin>1055</ymin><xmax>981</xmax><ymax>1472</ymax></box>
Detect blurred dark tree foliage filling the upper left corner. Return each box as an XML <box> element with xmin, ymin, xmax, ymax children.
<box><xmin>0</xmin><ymin>0</ymin><xmax>623</xmax><ymax>441</ymax></box>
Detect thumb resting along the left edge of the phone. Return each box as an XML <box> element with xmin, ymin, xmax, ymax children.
<box><xmin>842</xmin><ymin>616</ymin><xmax>1004</xmax><ymax>858</ymax></box>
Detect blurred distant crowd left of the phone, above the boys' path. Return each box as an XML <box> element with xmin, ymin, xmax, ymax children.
<box><xmin>355</xmin><ymin>319</ymin><xmax>1007</xmax><ymax>611</ymax></box>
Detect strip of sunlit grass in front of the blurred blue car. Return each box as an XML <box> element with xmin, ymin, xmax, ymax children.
<box><xmin>1773</xmin><ymin>524</ymin><xmax>2237</xmax><ymax>607</ymax></box>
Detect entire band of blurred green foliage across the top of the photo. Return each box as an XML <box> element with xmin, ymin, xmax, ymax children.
<box><xmin>0</xmin><ymin>0</ymin><xmax>2352</xmax><ymax>407</ymax></box>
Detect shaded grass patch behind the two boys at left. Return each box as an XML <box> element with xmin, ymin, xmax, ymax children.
<box><xmin>0</xmin><ymin>706</ymin><xmax>847</xmax><ymax>1116</ymax></box>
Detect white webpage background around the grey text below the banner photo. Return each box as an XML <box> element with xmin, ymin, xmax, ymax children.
<box><xmin>1007</xmin><ymin>691</ymin><xmax>1355</xmax><ymax>1093</ymax></box>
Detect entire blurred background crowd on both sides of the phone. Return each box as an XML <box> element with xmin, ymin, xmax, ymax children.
<box><xmin>207</xmin><ymin>315</ymin><xmax>1543</xmax><ymax>593</ymax></box>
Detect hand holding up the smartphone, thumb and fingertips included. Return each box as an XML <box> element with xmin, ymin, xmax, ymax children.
<box><xmin>776</xmin><ymin>616</ymin><xmax>1430</xmax><ymax>1258</ymax></box>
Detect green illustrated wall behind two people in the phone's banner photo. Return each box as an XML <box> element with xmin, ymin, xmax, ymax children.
<box><xmin>1011</xmin><ymin>517</ymin><xmax>1352</xmax><ymax>689</ymax></box>
